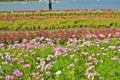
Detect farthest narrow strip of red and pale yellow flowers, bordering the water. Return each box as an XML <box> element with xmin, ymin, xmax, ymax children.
<box><xmin>0</xmin><ymin>10</ymin><xmax>120</xmax><ymax>16</ymax></box>
